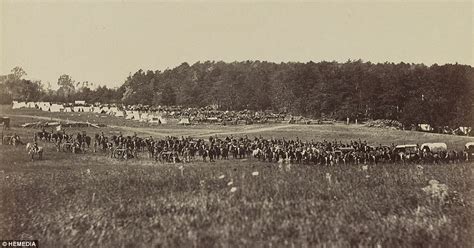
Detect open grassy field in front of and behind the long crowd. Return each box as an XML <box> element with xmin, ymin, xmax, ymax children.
<box><xmin>0</xmin><ymin>105</ymin><xmax>474</xmax><ymax>247</ymax></box>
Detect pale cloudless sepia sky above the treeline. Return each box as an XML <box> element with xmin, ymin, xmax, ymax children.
<box><xmin>0</xmin><ymin>0</ymin><xmax>474</xmax><ymax>86</ymax></box>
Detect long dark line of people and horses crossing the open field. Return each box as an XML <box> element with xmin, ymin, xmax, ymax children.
<box><xmin>27</xmin><ymin>130</ymin><xmax>472</xmax><ymax>165</ymax></box>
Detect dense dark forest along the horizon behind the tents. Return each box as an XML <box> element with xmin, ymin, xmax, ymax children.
<box><xmin>0</xmin><ymin>60</ymin><xmax>474</xmax><ymax>127</ymax></box>
